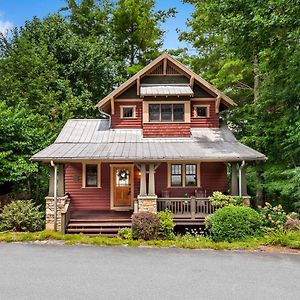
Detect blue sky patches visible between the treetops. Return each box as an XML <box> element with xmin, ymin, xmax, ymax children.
<box><xmin>0</xmin><ymin>0</ymin><xmax>193</xmax><ymax>49</ymax></box>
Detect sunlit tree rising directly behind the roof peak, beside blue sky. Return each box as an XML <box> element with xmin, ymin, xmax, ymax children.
<box><xmin>112</xmin><ymin>0</ymin><xmax>176</xmax><ymax>75</ymax></box>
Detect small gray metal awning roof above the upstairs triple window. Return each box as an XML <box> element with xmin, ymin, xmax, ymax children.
<box><xmin>140</xmin><ymin>84</ymin><xmax>194</xmax><ymax>97</ymax></box>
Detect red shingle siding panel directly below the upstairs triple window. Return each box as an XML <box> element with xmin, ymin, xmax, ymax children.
<box><xmin>143</xmin><ymin>123</ymin><xmax>191</xmax><ymax>137</ymax></box>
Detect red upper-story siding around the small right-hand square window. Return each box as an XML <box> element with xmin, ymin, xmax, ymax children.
<box><xmin>191</xmin><ymin>100</ymin><xmax>220</xmax><ymax>128</ymax></box>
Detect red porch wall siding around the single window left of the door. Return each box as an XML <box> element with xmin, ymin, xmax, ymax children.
<box><xmin>65</xmin><ymin>163</ymin><xmax>110</xmax><ymax>210</ymax></box>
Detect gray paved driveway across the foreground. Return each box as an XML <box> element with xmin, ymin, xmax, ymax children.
<box><xmin>0</xmin><ymin>244</ymin><xmax>300</xmax><ymax>300</ymax></box>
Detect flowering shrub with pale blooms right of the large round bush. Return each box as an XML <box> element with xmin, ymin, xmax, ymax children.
<box><xmin>258</xmin><ymin>202</ymin><xmax>288</xmax><ymax>230</ymax></box>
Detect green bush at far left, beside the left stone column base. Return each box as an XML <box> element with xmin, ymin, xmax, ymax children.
<box><xmin>0</xmin><ymin>200</ymin><xmax>45</xmax><ymax>232</ymax></box>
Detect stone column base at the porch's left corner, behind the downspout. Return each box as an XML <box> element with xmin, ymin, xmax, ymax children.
<box><xmin>45</xmin><ymin>196</ymin><xmax>70</xmax><ymax>231</ymax></box>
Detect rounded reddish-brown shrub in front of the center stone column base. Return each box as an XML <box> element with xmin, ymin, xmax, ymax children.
<box><xmin>132</xmin><ymin>212</ymin><xmax>159</xmax><ymax>241</ymax></box>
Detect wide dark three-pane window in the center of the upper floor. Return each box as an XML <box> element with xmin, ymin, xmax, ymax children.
<box><xmin>149</xmin><ymin>104</ymin><xmax>184</xmax><ymax>122</ymax></box>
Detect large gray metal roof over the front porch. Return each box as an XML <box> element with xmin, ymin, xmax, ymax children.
<box><xmin>32</xmin><ymin>119</ymin><xmax>266</xmax><ymax>162</ymax></box>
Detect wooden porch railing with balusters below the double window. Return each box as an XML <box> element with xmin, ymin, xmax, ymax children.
<box><xmin>157</xmin><ymin>197</ymin><xmax>216</xmax><ymax>219</ymax></box>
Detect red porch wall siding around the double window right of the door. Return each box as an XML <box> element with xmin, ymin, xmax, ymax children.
<box><xmin>155</xmin><ymin>162</ymin><xmax>227</xmax><ymax>197</ymax></box>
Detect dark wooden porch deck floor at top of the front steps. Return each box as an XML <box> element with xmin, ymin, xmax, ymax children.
<box><xmin>71</xmin><ymin>210</ymin><xmax>133</xmax><ymax>221</ymax></box>
